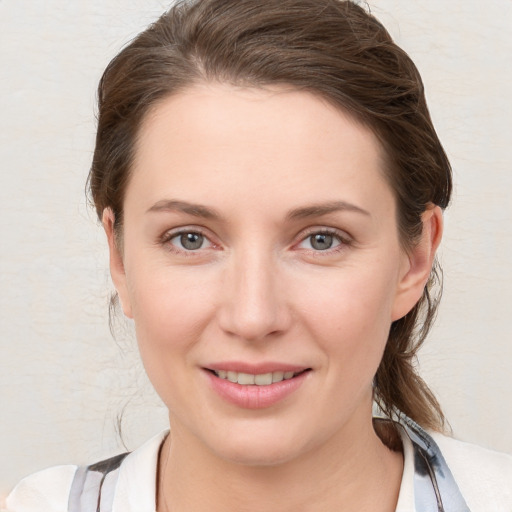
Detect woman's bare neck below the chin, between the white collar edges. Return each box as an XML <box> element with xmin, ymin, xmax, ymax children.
<box><xmin>158</xmin><ymin>410</ymin><xmax>403</xmax><ymax>512</ymax></box>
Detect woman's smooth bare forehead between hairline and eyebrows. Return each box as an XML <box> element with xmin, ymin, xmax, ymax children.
<box><xmin>127</xmin><ymin>84</ymin><xmax>391</xmax><ymax>218</ymax></box>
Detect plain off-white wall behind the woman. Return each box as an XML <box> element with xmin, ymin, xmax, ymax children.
<box><xmin>0</xmin><ymin>0</ymin><xmax>512</xmax><ymax>494</ymax></box>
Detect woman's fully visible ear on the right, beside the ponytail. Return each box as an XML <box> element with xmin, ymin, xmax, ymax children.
<box><xmin>391</xmin><ymin>204</ymin><xmax>443</xmax><ymax>321</ymax></box>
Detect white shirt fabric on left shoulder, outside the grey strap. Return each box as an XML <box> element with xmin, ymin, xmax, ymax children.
<box><xmin>6</xmin><ymin>465</ymin><xmax>77</xmax><ymax>512</ymax></box>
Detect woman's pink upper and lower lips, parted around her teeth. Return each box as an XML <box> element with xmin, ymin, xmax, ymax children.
<box><xmin>203</xmin><ymin>363</ymin><xmax>311</xmax><ymax>409</ymax></box>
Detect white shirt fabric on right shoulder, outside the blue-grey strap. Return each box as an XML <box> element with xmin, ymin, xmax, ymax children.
<box><xmin>431</xmin><ymin>433</ymin><xmax>512</xmax><ymax>512</ymax></box>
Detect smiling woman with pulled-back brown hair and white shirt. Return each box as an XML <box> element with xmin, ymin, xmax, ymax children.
<box><xmin>7</xmin><ymin>0</ymin><xmax>512</xmax><ymax>512</ymax></box>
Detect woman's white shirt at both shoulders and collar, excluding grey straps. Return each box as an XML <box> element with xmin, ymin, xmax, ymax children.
<box><xmin>6</xmin><ymin>431</ymin><xmax>512</xmax><ymax>512</ymax></box>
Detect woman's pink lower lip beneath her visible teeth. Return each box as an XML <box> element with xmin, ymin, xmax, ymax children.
<box><xmin>205</xmin><ymin>370</ymin><xmax>310</xmax><ymax>409</ymax></box>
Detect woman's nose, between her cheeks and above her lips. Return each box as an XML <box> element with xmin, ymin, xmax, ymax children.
<box><xmin>218</xmin><ymin>250</ymin><xmax>291</xmax><ymax>341</ymax></box>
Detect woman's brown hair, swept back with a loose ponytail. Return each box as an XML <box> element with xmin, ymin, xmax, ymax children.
<box><xmin>89</xmin><ymin>0</ymin><xmax>452</xmax><ymax>430</ymax></box>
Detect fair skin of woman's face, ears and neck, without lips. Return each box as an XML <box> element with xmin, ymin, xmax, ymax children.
<box><xmin>103</xmin><ymin>84</ymin><xmax>442</xmax><ymax>512</ymax></box>
